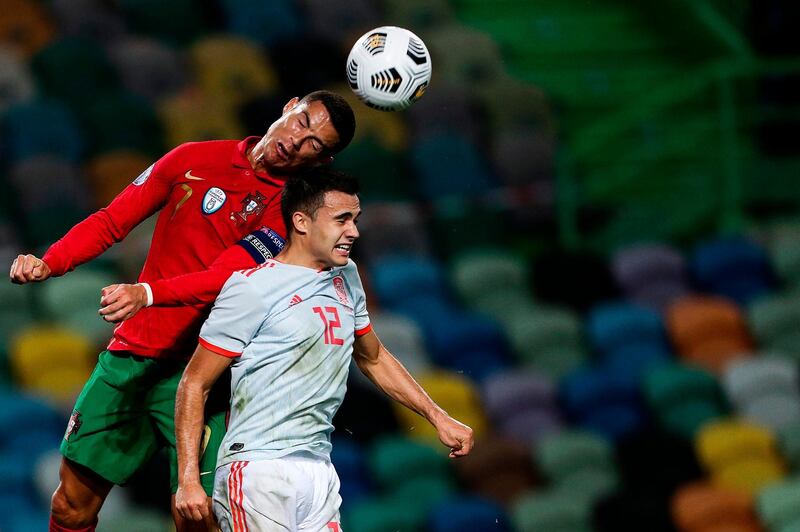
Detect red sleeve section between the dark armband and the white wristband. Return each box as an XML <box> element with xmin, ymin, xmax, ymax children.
<box><xmin>148</xmin><ymin>245</ymin><xmax>257</xmax><ymax>307</ymax></box>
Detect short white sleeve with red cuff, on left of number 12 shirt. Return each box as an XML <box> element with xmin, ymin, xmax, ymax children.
<box><xmin>200</xmin><ymin>272</ymin><xmax>266</xmax><ymax>357</ymax></box>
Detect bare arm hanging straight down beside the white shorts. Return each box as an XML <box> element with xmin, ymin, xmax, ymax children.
<box><xmin>175</xmin><ymin>345</ymin><xmax>232</xmax><ymax>521</ymax></box>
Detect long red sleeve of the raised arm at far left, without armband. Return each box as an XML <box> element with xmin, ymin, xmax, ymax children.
<box><xmin>42</xmin><ymin>146</ymin><xmax>181</xmax><ymax>276</ymax></box>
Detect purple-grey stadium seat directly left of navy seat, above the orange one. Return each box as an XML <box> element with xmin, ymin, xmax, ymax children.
<box><xmin>611</xmin><ymin>244</ymin><xmax>689</xmax><ymax>310</ymax></box>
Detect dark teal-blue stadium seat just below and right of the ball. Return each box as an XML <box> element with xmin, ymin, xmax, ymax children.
<box><xmin>410</xmin><ymin>133</ymin><xmax>493</xmax><ymax>201</ymax></box>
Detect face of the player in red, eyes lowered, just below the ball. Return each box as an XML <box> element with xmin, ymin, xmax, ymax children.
<box><xmin>249</xmin><ymin>98</ymin><xmax>339</xmax><ymax>174</ymax></box>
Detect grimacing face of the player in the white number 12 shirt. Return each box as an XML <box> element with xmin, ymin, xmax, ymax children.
<box><xmin>308</xmin><ymin>191</ymin><xmax>361</xmax><ymax>268</ymax></box>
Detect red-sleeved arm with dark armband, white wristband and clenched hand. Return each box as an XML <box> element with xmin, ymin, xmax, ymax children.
<box><xmin>99</xmin><ymin>222</ymin><xmax>285</xmax><ymax>323</ymax></box>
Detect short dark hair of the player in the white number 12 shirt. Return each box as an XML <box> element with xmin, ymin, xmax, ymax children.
<box><xmin>281</xmin><ymin>166</ymin><xmax>358</xmax><ymax>237</ymax></box>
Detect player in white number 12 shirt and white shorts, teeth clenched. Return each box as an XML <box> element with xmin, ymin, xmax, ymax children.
<box><xmin>175</xmin><ymin>168</ymin><xmax>473</xmax><ymax>532</ymax></box>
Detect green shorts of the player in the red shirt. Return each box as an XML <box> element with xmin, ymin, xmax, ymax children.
<box><xmin>61</xmin><ymin>351</ymin><xmax>225</xmax><ymax>496</ymax></box>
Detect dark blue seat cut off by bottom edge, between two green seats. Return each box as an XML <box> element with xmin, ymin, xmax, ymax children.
<box><xmin>428</xmin><ymin>497</ymin><xmax>511</xmax><ymax>532</ymax></box>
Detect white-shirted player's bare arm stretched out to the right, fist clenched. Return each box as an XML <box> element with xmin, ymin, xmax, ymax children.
<box><xmin>353</xmin><ymin>330</ymin><xmax>474</xmax><ymax>458</ymax></box>
